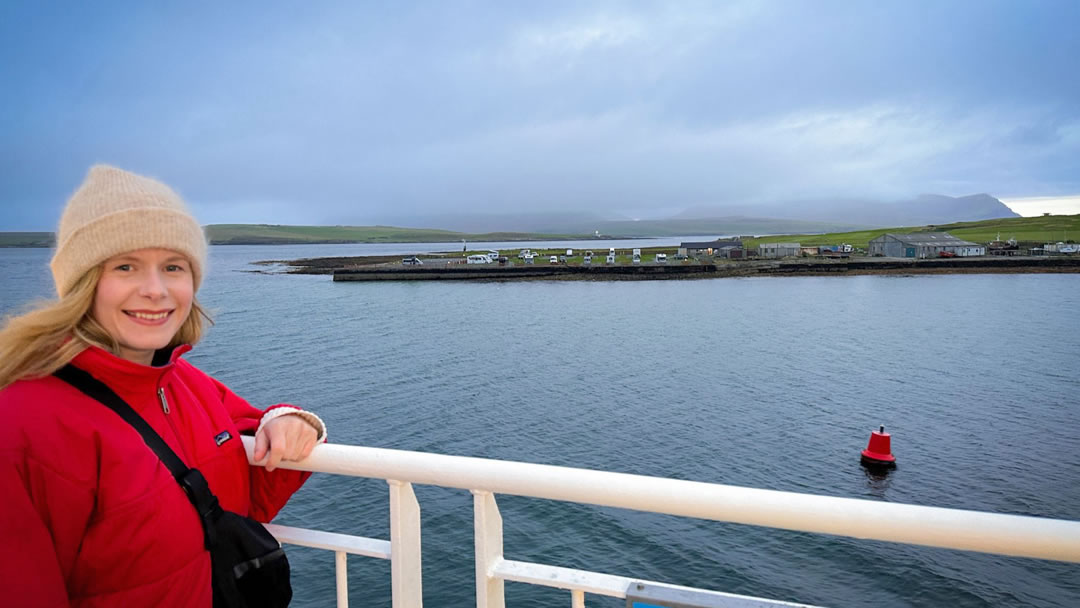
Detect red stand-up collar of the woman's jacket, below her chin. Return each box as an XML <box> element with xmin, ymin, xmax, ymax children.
<box><xmin>71</xmin><ymin>344</ymin><xmax>191</xmax><ymax>397</ymax></box>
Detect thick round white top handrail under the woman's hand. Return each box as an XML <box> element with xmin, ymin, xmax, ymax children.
<box><xmin>244</xmin><ymin>437</ymin><xmax>1080</xmax><ymax>563</ymax></box>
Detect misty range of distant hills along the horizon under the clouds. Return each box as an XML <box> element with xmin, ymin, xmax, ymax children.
<box><xmin>0</xmin><ymin>194</ymin><xmax>1028</xmax><ymax>247</ymax></box>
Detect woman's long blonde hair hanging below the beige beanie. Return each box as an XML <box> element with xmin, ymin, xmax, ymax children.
<box><xmin>0</xmin><ymin>266</ymin><xmax>213</xmax><ymax>390</ymax></box>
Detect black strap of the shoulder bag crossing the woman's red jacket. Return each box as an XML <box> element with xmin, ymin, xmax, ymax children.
<box><xmin>53</xmin><ymin>363</ymin><xmax>221</xmax><ymax>549</ymax></box>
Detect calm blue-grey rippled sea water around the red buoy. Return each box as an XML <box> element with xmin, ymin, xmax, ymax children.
<box><xmin>0</xmin><ymin>243</ymin><xmax>1080</xmax><ymax>608</ymax></box>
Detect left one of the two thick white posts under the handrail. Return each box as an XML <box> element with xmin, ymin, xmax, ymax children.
<box><xmin>387</xmin><ymin>479</ymin><xmax>423</xmax><ymax>608</ymax></box>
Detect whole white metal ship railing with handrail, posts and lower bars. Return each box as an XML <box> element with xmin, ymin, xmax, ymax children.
<box><xmin>243</xmin><ymin>437</ymin><xmax>1080</xmax><ymax>608</ymax></box>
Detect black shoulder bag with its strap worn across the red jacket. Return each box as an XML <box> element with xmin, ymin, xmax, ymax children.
<box><xmin>55</xmin><ymin>364</ymin><xmax>293</xmax><ymax>608</ymax></box>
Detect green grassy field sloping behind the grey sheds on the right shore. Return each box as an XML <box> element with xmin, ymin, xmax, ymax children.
<box><xmin>745</xmin><ymin>214</ymin><xmax>1080</xmax><ymax>249</ymax></box>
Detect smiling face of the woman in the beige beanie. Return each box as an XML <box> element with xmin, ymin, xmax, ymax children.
<box><xmin>92</xmin><ymin>249</ymin><xmax>194</xmax><ymax>365</ymax></box>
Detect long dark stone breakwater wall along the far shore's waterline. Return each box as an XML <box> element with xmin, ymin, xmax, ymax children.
<box><xmin>317</xmin><ymin>257</ymin><xmax>1080</xmax><ymax>281</ymax></box>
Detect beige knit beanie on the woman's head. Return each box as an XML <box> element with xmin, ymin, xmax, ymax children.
<box><xmin>50</xmin><ymin>165</ymin><xmax>206</xmax><ymax>298</ymax></box>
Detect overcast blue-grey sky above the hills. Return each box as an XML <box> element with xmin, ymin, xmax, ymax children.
<box><xmin>0</xmin><ymin>0</ymin><xmax>1080</xmax><ymax>230</ymax></box>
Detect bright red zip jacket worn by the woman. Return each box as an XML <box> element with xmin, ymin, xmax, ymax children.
<box><xmin>0</xmin><ymin>347</ymin><xmax>310</xmax><ymax>608</ymax></box>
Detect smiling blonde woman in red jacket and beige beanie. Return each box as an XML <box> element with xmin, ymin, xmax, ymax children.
<box><xmin>0</xmin><ymin>166</ymin><xmax>326</xmax><ymax>608</ymax></box>
